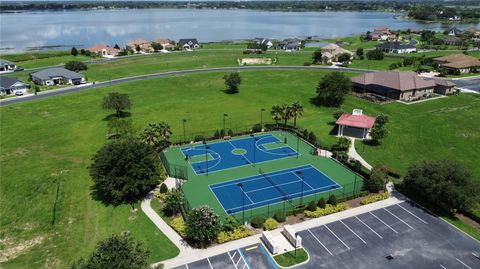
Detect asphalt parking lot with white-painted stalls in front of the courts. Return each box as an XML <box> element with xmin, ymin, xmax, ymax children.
<box><xmin>171</xmin><ymin>202</ymin><xmax>480</xmax><ymax>269</ymax></box>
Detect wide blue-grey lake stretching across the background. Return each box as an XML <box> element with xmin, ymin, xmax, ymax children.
<box><xmin>0</xmin><ymin>9</ymin><xmax>480</xmax><ymax>53</ymax></box>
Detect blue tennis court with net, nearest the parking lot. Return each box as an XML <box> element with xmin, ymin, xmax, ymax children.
<box><xmin>210</xmin><ymin>165</ymin><xmax>341</xmax><ymax>214</ymax></box>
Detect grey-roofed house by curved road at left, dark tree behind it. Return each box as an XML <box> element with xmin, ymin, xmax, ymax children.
<box><xmin>30</xmin><ymin>67</ymin><xmax>85</xmax><ymax>86</ymax></box>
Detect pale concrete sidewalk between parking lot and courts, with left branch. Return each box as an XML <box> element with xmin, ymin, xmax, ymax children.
<box><xmin>141</xmin><ymin>181</ymin><xmax>404</xmax><ymax>268</ymax></box>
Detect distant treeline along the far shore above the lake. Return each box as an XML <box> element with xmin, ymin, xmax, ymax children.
<box><xmin>0</xmin><ymin>0</ymin><xmax>480</xmax><ymax>20</ymax></box>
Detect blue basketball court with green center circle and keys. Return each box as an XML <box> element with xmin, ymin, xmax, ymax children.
<box><xmin>181</xmin><ymin>134</ymin><xmax>298</xmax><ymax>175</ymax></box>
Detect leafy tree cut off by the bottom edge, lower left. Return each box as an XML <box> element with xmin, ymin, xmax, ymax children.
<box><xmin>71</xmin><ymin>232</ymin><xmax>150</xmax><ymax>269</ymax></box>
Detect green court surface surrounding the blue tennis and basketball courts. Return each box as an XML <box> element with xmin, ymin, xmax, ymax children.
<box><xmin>164</xmin><ymin>131</ymin><xmax>363</xmax><ymax>221</ymax></box>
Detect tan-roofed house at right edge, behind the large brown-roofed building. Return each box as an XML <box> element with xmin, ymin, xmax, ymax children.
<box><xmin>432</xmin><ymin>54</ymin><xmax>480</xmax><ymax>74</ymax></box>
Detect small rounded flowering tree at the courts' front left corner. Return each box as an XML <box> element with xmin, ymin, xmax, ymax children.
<box><xmin>185</xmin><ymin>205</ymin><xmax>220</xmax><ymax>247</ymax></box>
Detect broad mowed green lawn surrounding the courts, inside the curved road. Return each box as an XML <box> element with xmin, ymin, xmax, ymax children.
<box><xmin>0</xmin><ymin>68</ymin><xmax>480</xmax><ymax>268</ymax></box>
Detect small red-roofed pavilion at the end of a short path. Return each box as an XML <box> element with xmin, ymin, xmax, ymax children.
<box><xmin>335</xmin><ymin>109</ymin><xmax>376</xmax><ymax>139</ymax></box>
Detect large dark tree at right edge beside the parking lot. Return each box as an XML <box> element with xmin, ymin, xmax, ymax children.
<box><xmin>403</xmin><ymin>160</ymin><xmax>480</xmax><ymax>211</ymax></box>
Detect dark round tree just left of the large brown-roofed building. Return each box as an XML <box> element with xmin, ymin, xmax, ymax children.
<box><xmin>313</xmin><ymin>72</ymin><xmax>352</xmax><ymax>107</ymax></box>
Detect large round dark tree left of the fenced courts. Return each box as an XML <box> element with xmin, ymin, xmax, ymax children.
<box><xmin>90</xmin><ymin>139</ymin><xmax>163</xmax><ymax>207</ymax></box>
